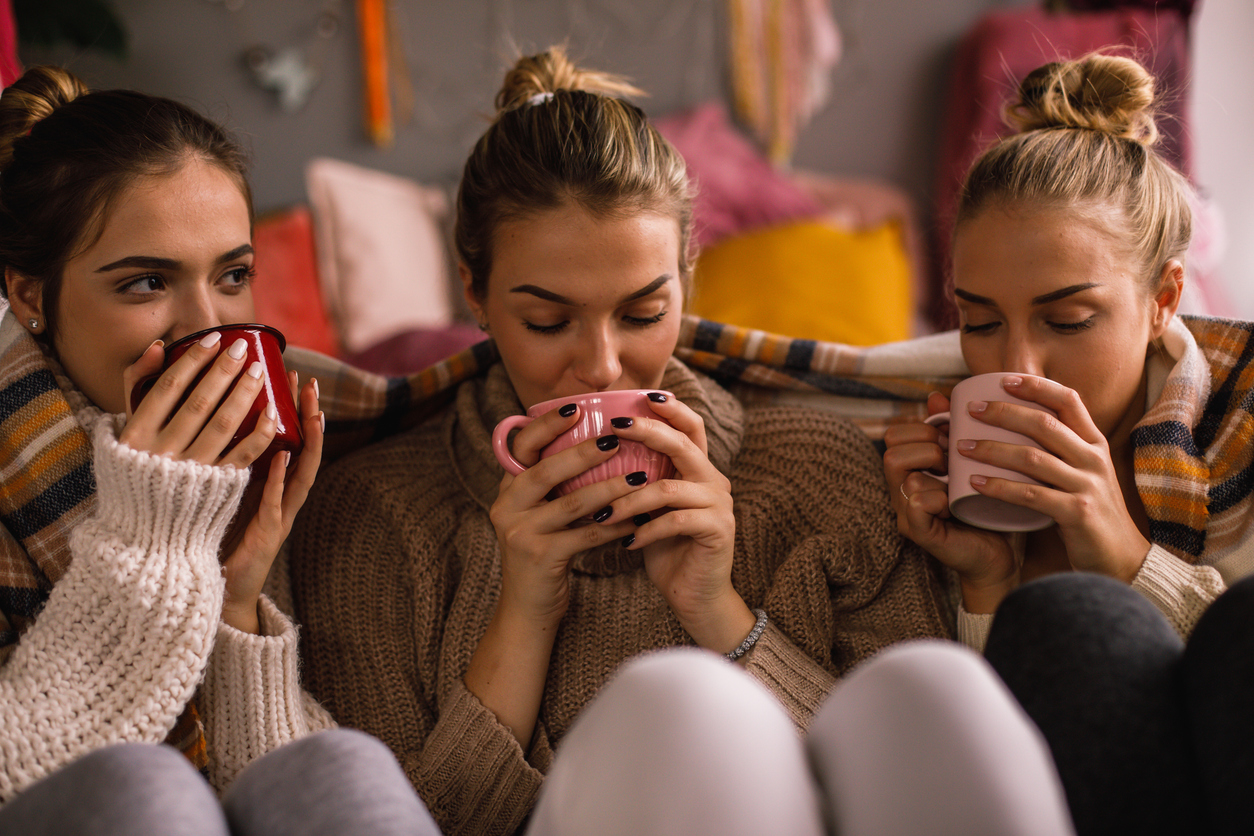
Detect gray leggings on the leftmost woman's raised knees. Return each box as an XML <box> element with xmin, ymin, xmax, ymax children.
<box><xmin>0</xmin><ymin>729</ymin><xmax>439</xmax><ymax>836</ymax></box>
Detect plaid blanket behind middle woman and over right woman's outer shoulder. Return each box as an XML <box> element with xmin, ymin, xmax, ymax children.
<box><xmin>288</xmin><ymin>310</ymin><xmax>1254</xmax><ymax>583</ymax></box>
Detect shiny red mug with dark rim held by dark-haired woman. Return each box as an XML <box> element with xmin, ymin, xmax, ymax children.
<box><xmin>130</xmin><ymin>322</ymin><xmax>305</xmax><ymax>474</ymax></box>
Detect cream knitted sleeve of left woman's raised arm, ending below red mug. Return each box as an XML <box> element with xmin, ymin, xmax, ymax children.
<box><xmin>0</xmin><ymin>416</ymin><xmax>248</xmax><ymax>801</ymax></box>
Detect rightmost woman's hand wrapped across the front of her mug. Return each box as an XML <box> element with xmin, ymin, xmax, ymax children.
<box><xmin>959</xmin><ymin>375</ymin><xmax>1150</xmax><ymax>583</ymax></box>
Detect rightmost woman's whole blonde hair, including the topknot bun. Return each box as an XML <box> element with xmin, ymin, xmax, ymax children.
<box><xmin>954</xmin><ymin>54</ymin><xmax>1193</xmax><ymax>290</ymax></box>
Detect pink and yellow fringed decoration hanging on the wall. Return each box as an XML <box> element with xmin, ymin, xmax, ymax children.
<box><xmin>727</xmin><ymin>0</ymin><xmax>840</xmax><ymax>165</ymax></box>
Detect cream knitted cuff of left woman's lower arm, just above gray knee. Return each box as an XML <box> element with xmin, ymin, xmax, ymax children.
<box><xmin>199</xmin><ymin>597</ymin><xmax>335</xmax><ymax>792</ymax></box>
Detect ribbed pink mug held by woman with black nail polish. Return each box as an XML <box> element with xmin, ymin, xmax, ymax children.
<box><xmin>492</xmin><ymin>389</ymin><xmax>675</xmax><ymax>495</ymax></box>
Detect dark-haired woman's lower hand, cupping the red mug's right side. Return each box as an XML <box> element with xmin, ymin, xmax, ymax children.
<box><xmin>222</xmin><ymin>371</ymin><xmax>324</xmax><ymax>633</ymax></box>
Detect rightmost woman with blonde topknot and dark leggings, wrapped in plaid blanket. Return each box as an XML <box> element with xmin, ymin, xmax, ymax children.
<box><xmin>884</xmin><ymin>54</ymin><xmax>1254</xmax><ymax>833</ymax></box>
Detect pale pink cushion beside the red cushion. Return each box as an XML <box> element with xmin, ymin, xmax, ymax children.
<box><xmin>305</xmin><ymin>158</ymin><xmax>453</xmax><ymax>352</ymax></box>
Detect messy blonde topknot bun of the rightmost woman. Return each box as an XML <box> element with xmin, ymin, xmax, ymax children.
<box><xmin>1006</xmin><ymin>54</ymin><xmax>1159</xmax><ymax>145</ymax></box>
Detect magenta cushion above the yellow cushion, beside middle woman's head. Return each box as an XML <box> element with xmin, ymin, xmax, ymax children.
<box><xmin>653</xmin><ymin>102</ymin><xmax>823</xmax><ymax>246</ymax></box>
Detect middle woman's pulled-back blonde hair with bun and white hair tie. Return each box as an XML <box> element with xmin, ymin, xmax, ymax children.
<box><xmin>454</xmin><ymin>46</ymin><xmax>693</xmax><ymax>298</ymax></box>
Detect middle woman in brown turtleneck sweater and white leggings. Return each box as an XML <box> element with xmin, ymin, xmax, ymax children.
<box><xmin>291</xmin><ymin>50</ymin><xmax>1066</xmax><ymax>833</ymax></box>
